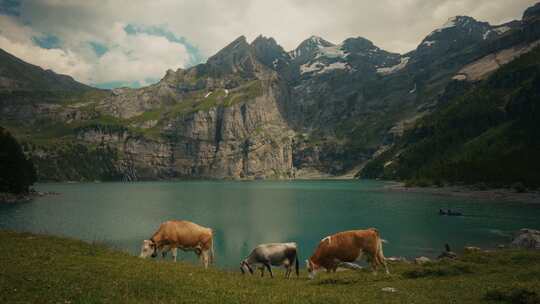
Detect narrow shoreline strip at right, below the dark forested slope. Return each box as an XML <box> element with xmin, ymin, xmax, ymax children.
<box><xmin>382</xmin><ymin>182</ymin><xmax>540</xmax><ymax>204</ymax></box>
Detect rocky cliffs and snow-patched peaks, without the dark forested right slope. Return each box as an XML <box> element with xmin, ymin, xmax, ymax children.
<box><xmin>0</xmin><ymin>2</ymin><xmax>540</xmax><ymax>180</ymax></box>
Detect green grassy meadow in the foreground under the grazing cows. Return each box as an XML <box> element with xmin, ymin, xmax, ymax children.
<box><xmin>0</xmin><ymin>231</ymin><xmax>540</xmax><ymax>303</ymax></box>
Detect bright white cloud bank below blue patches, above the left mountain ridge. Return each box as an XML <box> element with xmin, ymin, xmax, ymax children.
<box><xmin>0</xmin><ymin>16</ymin><xmax>190</xmax><ymax>84</ymax></box>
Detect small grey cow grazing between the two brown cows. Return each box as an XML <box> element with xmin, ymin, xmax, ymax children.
<box><xmin>240</xmin><ymin>243</ymin><xmax>300</xmax><ymax>278</ymax></box>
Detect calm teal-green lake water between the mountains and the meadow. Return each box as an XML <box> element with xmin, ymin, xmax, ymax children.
<box><xmin>0</xmin><ymin>181</ymin><xmax>540</xmax><ymax>268</ymax></box>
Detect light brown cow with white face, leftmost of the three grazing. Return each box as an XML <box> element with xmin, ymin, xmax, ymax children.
<box><xmin>140</xmin><ymin>221</ymin><xmax>214</xmax><ymax>268</ymax></box>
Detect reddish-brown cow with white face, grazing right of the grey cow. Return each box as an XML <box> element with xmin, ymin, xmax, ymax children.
<box><xmin>306</xmin><ymin>228</ymin><xmax>390</xmax><ymax>279</ymax></box>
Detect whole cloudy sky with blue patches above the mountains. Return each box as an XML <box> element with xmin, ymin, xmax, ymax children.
<box><xmin>0</xmin><ymin>0</ymin><xmax>538</xmax><ymax>88</ymax></box>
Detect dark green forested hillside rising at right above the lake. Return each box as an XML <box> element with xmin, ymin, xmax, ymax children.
<box><xmin>362</xmin><ymin>48</ymin><xmax>540</xmax><ymax>187</ymax></box>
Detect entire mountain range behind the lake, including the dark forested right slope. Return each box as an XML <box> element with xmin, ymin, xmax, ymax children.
<box><xmin>0</xmin><ymin>4</ymin><xmax>540</xmax><ymax>184</ymax></box>
